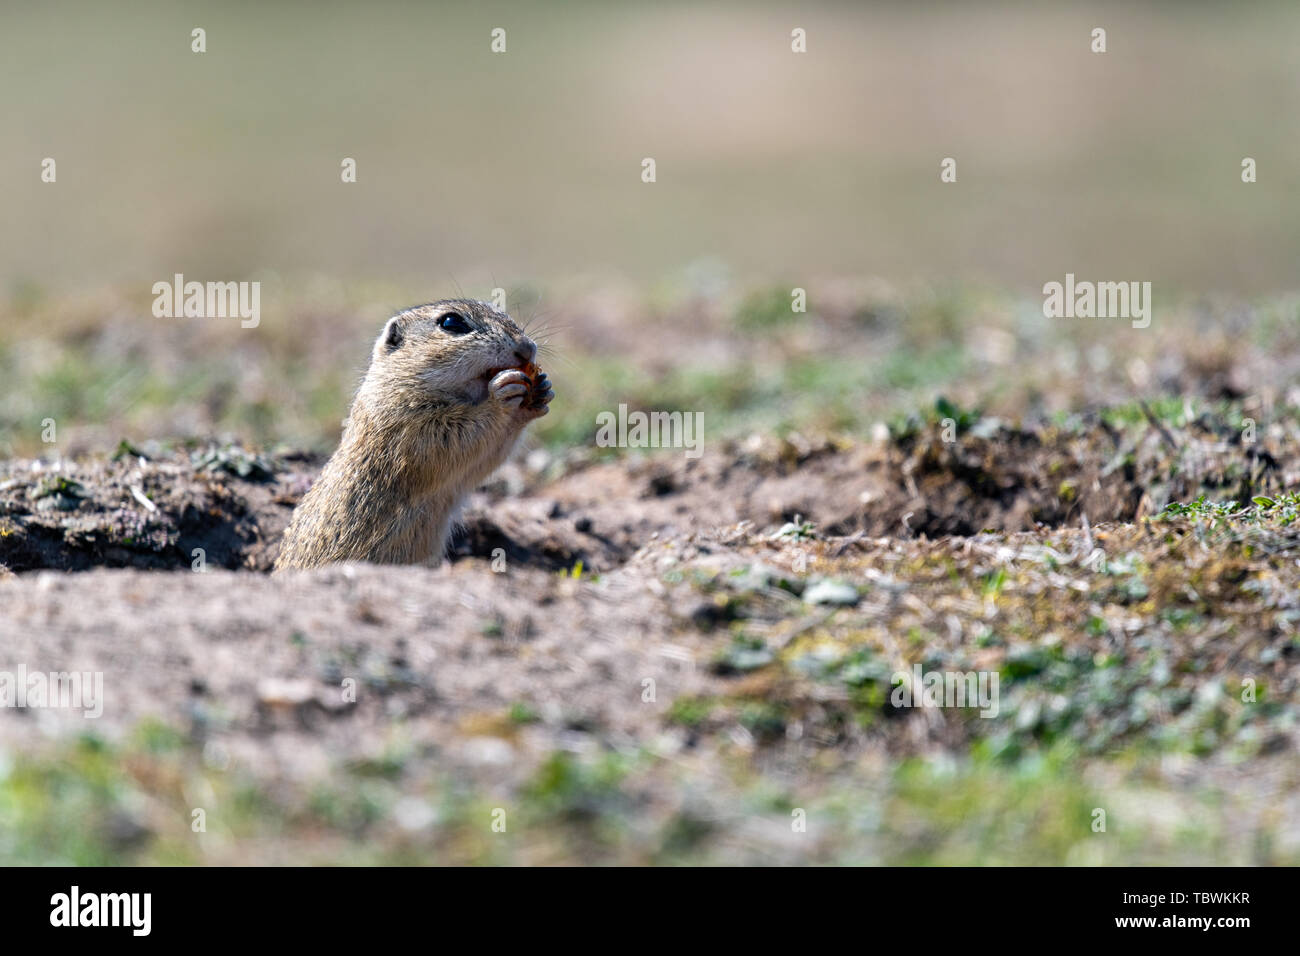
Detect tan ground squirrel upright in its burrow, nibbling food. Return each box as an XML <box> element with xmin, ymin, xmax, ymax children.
<box><xmin>276</xmin><ymin>299</ymin><xmax>554</xmax><ymax>571</ymax></box>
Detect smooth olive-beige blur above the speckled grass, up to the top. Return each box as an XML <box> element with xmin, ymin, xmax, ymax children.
<box><xmin>0</xmin><ymin>0</ymin><xmax>1300</xmax><ymax>291</ymax></box>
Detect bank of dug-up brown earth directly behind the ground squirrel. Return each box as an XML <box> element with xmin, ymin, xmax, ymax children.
<box><xmin>0</xmin><ymin>416</ymin><xmax>1300</xmax><ymax>572</ymax></box>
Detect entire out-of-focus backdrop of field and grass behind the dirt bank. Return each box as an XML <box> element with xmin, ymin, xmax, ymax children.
<box><xmin>0</xmin><ymin>0</ymin><xmax>1300</xmax><ymax>455</ymax></box>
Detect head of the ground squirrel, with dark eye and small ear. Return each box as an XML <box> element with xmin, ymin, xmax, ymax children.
<box><xmin>361</xmin><ymin>299</ymin><xmax>537</xmax><ymax>406</ymax></box>
